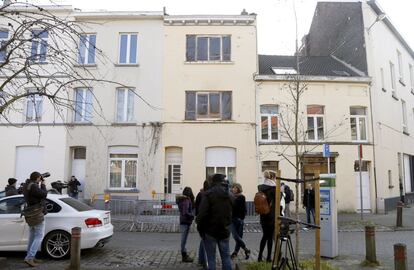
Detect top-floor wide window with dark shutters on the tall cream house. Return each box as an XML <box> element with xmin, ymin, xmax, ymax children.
<box><xmin>186</xmin><ymin>35</ymin><xmax>231</xmax><ymax>62</ymax></box>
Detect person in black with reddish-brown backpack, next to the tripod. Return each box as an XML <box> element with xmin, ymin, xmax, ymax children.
<box><xmin>255</xmin><ymin>170</ymin><xmax>285</xmax><ymax>262</ymax></box>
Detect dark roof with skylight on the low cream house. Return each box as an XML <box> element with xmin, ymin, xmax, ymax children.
<box><xmin>259</xmin><ymin>55</ymin><xmax>364</xmax><ymax>77</ymax></box>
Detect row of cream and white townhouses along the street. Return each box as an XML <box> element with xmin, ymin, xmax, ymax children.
<box><xmin>0</xmin><ymin>1</ymin><xmax>414</xmax><ymax>212</ymax></box>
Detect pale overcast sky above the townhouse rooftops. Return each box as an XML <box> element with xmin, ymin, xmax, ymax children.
<box><xmin>29</xmin><ymin>0</ymin><xmax>414</xmax><ymax>54</ymax></box>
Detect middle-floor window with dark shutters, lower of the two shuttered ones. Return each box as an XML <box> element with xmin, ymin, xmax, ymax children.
<box><xmin>185</xmin><ymin>91</ymin><xmax>232</xmax><ymax>120</ymax></box>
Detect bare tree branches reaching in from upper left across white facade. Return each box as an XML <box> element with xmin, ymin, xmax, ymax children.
<box><xmin>0</xmin><ymin>1</ymin><xmax>151</xmax><ymax>123</ymax></box>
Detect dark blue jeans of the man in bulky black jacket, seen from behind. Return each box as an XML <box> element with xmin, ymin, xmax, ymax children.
<box><xmin>203</xmin><ymin>234</ymin><xmax>232</xmax><ymax>270</ymax></box>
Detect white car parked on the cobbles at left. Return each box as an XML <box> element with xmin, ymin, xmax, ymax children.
<box><xmin>0</xmin><ymin>194</ymin><xmax>113</xmax><ymax>259</ymax></box>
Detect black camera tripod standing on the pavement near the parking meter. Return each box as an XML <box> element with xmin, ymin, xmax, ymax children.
<box><xmin>272</xmin><ymin>225</ymin><xmax>299</xmax><ymax>270</ymax></box>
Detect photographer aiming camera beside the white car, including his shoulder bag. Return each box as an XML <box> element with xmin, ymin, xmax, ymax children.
<box><xmin>23</xmin><ymin>172</ymin><xmax>50</xmax><ymax>267</ymax></box>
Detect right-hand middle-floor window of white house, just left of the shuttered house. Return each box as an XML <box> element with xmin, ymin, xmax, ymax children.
<box><xmin>116</xmin><ymin>88</ymin><xmax>135</xmax><ymax>122</ymax></box>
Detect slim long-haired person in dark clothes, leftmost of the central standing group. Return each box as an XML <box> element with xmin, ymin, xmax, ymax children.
<box><xmin>176</xmin><ymin>187</ymin><xmax>194</xmax><ymax>262</ymax></box>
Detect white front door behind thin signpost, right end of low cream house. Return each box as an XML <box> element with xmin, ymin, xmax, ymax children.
<box><xmin>354</xmin><ymin>161</ymin><xmax>371</xmax><ymax>213</ymax></box>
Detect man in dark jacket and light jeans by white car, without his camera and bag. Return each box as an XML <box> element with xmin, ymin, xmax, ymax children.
<box><xmin>23</xmin><ymin>172</ymin><xmax>47</xmax><ymax>267</ymax></box>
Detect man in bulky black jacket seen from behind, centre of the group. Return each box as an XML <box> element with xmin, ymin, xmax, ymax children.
<box><xmin>196</xmin><ymin>174</ymin><xmax>233</xmax><ymax>270</ymax></box>
